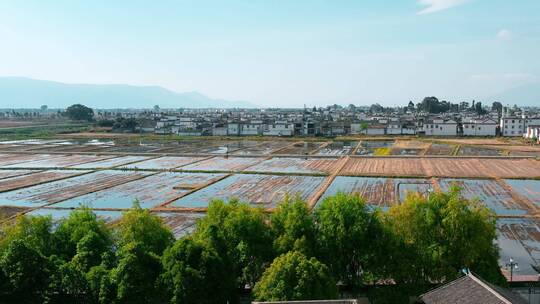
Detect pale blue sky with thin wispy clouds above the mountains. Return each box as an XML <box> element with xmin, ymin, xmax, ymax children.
<box><xmin>0</xmin><ymin>0</ymin><xmax>540</xmax><ymax>107</ymax></box>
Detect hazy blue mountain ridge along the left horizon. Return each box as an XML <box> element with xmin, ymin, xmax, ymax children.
<box><xmin>0</xmin><ymin>77</ymin><xmax>256</xmax><ymax>109</ymax></box>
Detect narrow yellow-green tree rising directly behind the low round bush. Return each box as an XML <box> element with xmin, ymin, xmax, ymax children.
<box><xmin>270</xmin><ymin>196</ymin><xmax>316</xmax><ymax>256</ymax></box>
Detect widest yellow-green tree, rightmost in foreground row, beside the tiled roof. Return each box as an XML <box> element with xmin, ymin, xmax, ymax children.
<box><xmin>388</xmin><ymin>186</ymin><xmax>505</xmax><ymax>285</ymax></box>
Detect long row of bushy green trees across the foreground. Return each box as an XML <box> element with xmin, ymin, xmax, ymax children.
<box><xmin>0</xmin><ymin>187</ymin><xmax>505</xmax><ymax>303</ymax></box>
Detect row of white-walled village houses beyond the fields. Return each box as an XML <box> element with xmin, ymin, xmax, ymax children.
<box><xmin>154</xmin><ymin>110</ymin><xmax>540</xmax><ymax>137</ymax></box>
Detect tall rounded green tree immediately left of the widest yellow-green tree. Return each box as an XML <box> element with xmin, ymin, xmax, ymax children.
<box><xmin>314</xmin><ymin>193</ymin><xmax>383</xmax><ymax>287</ymax></box>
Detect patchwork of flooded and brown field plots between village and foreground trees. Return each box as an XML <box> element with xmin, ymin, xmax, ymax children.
<box><xmin>0</xmin><ymin>138</ymin><xmax>540</xmax><ymax>275</ymax></box>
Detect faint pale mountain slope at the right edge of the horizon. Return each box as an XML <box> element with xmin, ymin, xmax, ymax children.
<box><xmin>486</xmin><ymin>83</ymin><xmax>540</xmax><ymax>107</ymax></box>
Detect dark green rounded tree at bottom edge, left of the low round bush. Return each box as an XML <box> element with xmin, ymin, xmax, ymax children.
<box><xmin>161</xmin><ymin>237</ymin><xmax>236</xmax><ymax>304</ymax></box>
